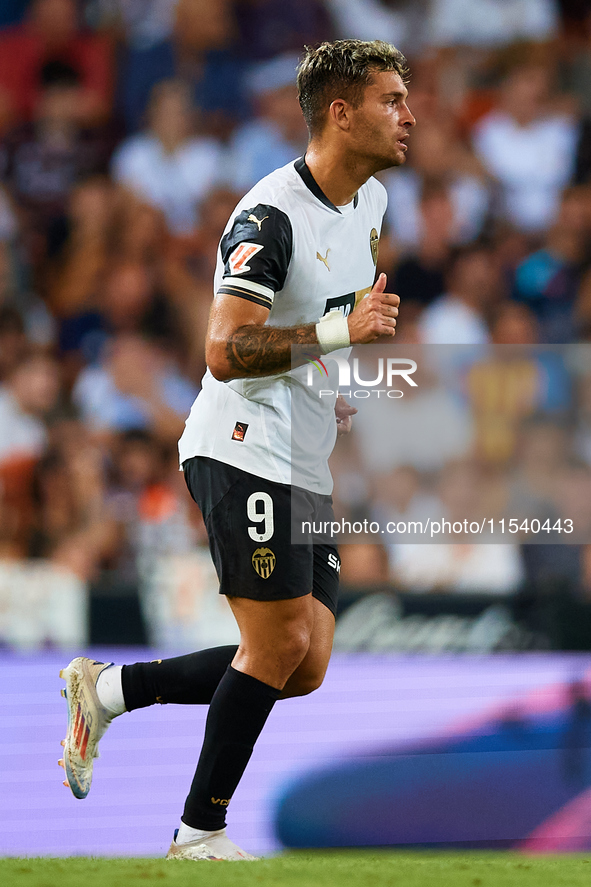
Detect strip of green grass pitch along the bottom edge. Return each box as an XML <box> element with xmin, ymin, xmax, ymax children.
<box><xmin>0</xmin><ymin>850</ymin><xmax>591</xmax><ymax>887</ymax></box>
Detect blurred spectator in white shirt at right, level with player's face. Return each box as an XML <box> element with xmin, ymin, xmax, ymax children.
<box><xmin>473</xmin><ymin>62</ymin><xmax>578</xmax><ymax>234</ymax></box>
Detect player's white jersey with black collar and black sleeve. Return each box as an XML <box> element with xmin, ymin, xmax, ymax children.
<box><xmin>179</xmin><ymin>158</ymin><xmax>387</xmax><ymax>494</ymax></box>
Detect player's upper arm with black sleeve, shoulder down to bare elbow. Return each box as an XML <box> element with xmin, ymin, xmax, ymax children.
<box><xmin>206</xmin><ymin>204</ymin><xmax>293</xmax><ymax>380</ymax></box>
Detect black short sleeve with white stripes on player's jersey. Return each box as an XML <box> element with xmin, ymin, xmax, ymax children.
<box><xmin>218</xmin><ymin>203</ymin><xmax>293</xmax><ymax>308</ymax></box>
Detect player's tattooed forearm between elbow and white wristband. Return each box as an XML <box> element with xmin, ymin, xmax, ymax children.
<box><xmin>226</xmin><ymin>323</ymin><xmax>320</xmax><ymax>377</ymax></box>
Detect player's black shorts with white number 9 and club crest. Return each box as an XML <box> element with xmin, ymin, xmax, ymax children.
<box><xmin>183</xmin><ymin>456</ymin><xmax>341</xmax><ymax>616</ymax></box>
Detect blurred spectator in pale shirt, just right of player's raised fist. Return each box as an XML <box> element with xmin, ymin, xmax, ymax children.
<box><xmin>418</xmin><ymin>244</ymin><xmax>504</xmax><ymax>345</ymax></box>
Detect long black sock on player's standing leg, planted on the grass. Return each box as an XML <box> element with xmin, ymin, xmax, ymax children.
<box><xmin>182</xmin><ymin>665</ymin><xmax>281</xmax><ymax>831</ymax></box>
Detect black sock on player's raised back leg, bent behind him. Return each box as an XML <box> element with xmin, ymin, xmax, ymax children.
<box><xmin>121</xmin><ymin>646</ymin><xmax>238</xmax><ymax>711</ymax></box>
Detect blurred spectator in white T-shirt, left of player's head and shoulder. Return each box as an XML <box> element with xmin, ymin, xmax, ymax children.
<box><xmin>112</xmin><ymin>80</ymin><xmax>222</xmax><ymax>234</ymax></box>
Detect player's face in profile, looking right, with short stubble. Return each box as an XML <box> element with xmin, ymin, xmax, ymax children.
<box><xmin>350</xmin><ymin>71</ymin><xmax>416</xmax><ymax>172</ymax></box>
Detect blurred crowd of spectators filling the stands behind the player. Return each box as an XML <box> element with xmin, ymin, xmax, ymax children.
<box><xmin>0</xmin><ymin>0</ymin><xmax>591</xmax><ymax>632</ymax></box>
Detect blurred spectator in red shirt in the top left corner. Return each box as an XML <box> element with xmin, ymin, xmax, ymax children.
<box><xmin>0</xmin><ymin>0</ymin><xmax>112</xmax><ymax>126</ymax></box>
